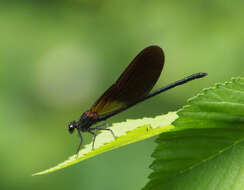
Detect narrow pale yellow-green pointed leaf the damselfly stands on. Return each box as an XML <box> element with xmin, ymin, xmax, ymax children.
<box><xmin>33</xmin><ymin>112</ymin><xmax>178</xmax><ymax>175</ymax></box>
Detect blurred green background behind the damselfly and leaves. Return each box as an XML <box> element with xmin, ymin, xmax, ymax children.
<box><xmin>0</xmin><ymin>0</ymin><xmax>244</xmax><ymax>190</ymax></box>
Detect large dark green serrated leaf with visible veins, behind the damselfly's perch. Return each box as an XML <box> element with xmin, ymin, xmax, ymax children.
<box><xmin>144</xmin><ymin>78</ymin><xmax>244</xmax><ymax>190</ymax></box>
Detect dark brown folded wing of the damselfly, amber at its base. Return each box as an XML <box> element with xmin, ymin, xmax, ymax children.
<box><xmin>91</xmin><ymin>46</ymin><xmax>164</xmax><ymax>115</ymax></box>
